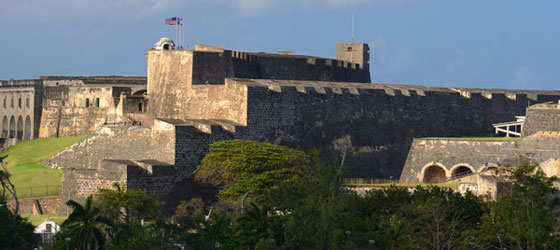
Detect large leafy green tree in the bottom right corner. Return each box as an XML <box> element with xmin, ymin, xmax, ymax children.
<box><xmin>473</xmin><ymin>164</ymin><xmax>560</xmax><ymax>249</ymax></box>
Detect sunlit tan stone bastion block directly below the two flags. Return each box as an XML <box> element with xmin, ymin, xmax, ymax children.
<box><xmin>147</xmin><ymin>51</ymin><xmax>247</xmax><ymax>124</ymax></box>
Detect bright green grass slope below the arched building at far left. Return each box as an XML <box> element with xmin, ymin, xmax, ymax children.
<box><xmin>0</xmin><ymin>136</ymin><xmax>85</xmax><ymax>198</ymax></box>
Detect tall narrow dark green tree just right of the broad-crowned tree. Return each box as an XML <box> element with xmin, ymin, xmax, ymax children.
<box><xmin>284</xmin><ymin>152</ymin><xmax>352</xmax><ymax>249</ymax></box>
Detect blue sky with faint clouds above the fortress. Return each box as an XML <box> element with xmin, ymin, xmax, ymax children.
<box><xmin>0</xmin><ymin>0</ymin><xmax>560</xmax><ymax>89</ymax></box>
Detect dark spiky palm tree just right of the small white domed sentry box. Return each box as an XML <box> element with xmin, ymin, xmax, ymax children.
<box><xmin>62</xmin><ymin>195</ymin><xmax>111</xmax><ymax>250</ymax></box>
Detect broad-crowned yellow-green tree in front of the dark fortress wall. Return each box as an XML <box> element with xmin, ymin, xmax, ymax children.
<box><xmin>194</xmin><ymin>140</ymin><xmax>309</xmax><ymax>206</ymax></box>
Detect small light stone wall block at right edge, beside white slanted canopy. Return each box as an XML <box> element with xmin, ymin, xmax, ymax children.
<box><xmin>522</xmin><ymin>104</ymin><xmax>560</xmax><ymax>136</ymax></box>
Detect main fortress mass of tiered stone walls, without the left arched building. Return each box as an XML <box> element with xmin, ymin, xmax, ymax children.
<box><xmin>32</xmin><ymin>39</ymin><xmax>560</xmax><ymax>215</ymax></box>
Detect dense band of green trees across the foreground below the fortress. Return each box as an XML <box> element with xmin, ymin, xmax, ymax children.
<box><xmin>32</xmin><ymin>141</ymin><xmax>560</xmax><ymax>250</ymax></box>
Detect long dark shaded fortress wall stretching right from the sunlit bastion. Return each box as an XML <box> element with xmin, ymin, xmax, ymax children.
<box><xmin>239</xmin><ymin>80</ymin><xmax>558</xmax><ymax>178</ymax></box>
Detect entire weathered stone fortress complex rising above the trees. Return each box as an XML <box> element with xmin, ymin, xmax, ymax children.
<box><xmin>0</xmin><ymin>39</ymin><xmax>560</xmax><ymax>214</ymax></box>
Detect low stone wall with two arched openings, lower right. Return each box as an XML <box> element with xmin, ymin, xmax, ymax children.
<box><xmin>400</xmin><ymin>139</ymin><xmax>516</xmax><ymax>182</ymax></box>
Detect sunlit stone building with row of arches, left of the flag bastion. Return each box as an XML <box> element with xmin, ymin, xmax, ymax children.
<box><xmin>0</xmin><ymin>76</ymin><xmax>146</xmax><ymax>147</ymax></box>
